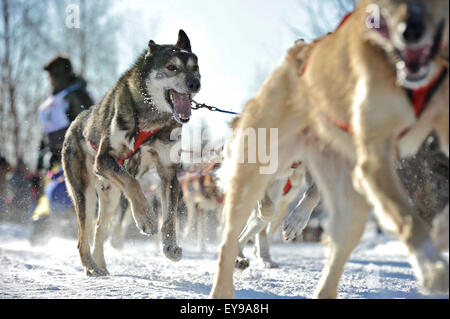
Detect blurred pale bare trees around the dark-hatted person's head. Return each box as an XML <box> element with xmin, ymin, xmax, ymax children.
<box><xmin>0</xmin><ymin>0</ymin><xmax>121</xmax><ymax>166</ymax></box>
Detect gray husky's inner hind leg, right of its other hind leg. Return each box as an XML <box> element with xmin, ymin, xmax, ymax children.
<box><xmin>92</xmin><ymin>180</ymin><xmax>121</xmax><ymax>274</ymax></box>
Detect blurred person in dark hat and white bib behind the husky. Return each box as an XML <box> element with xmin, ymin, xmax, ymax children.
<box><xmin>33</xmin><ymin>56</ymin><xmax>93</xmax><ymax>226</ymax></box>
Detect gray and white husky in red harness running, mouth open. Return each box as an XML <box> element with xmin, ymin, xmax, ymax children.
<box><xmin>62</xmin><ymin>30</ymin><xmax>200</xmax><ymax>276</ymax></box>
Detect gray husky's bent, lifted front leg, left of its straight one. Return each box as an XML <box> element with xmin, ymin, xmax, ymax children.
<box><xmin>94</xmin><ymin>138</ymin><xmax>158</xmax><ymax>235</ymax></box>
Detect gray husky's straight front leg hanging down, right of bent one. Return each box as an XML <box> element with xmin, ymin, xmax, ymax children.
<box><xmin>157</xmin><ymin>165</ymin><xmax>182</xmax><ymax>261</ymax></box>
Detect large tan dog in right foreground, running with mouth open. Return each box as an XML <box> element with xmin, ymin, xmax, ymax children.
<box><xmin>211</xmin><ymin>0</ymin><xmax>449</xmax><ymax>298</ymax></box>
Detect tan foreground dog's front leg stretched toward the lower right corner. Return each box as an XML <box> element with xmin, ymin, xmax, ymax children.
<box><xmin>353</xmin><ymin>104</ymin><xmax>449</xmax><ymax>293</ymax></box>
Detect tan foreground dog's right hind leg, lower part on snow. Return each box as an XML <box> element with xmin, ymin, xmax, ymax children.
<box><xmin>311</xmin><ymin>150</ymin><xmax>369</xmax><ymax>299</ymax></box>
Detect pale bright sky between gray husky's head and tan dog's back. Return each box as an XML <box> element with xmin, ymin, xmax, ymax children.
<box><xmin>112</xmin><ymin>0</ymin><xmax>346</xmax><ymax>146</ymax></box>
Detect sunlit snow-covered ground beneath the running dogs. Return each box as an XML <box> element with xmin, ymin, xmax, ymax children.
<box><xmin>0</xmin><ymin>223</ymin><xmax>448</xmax><ymax>299</ymax></box>
